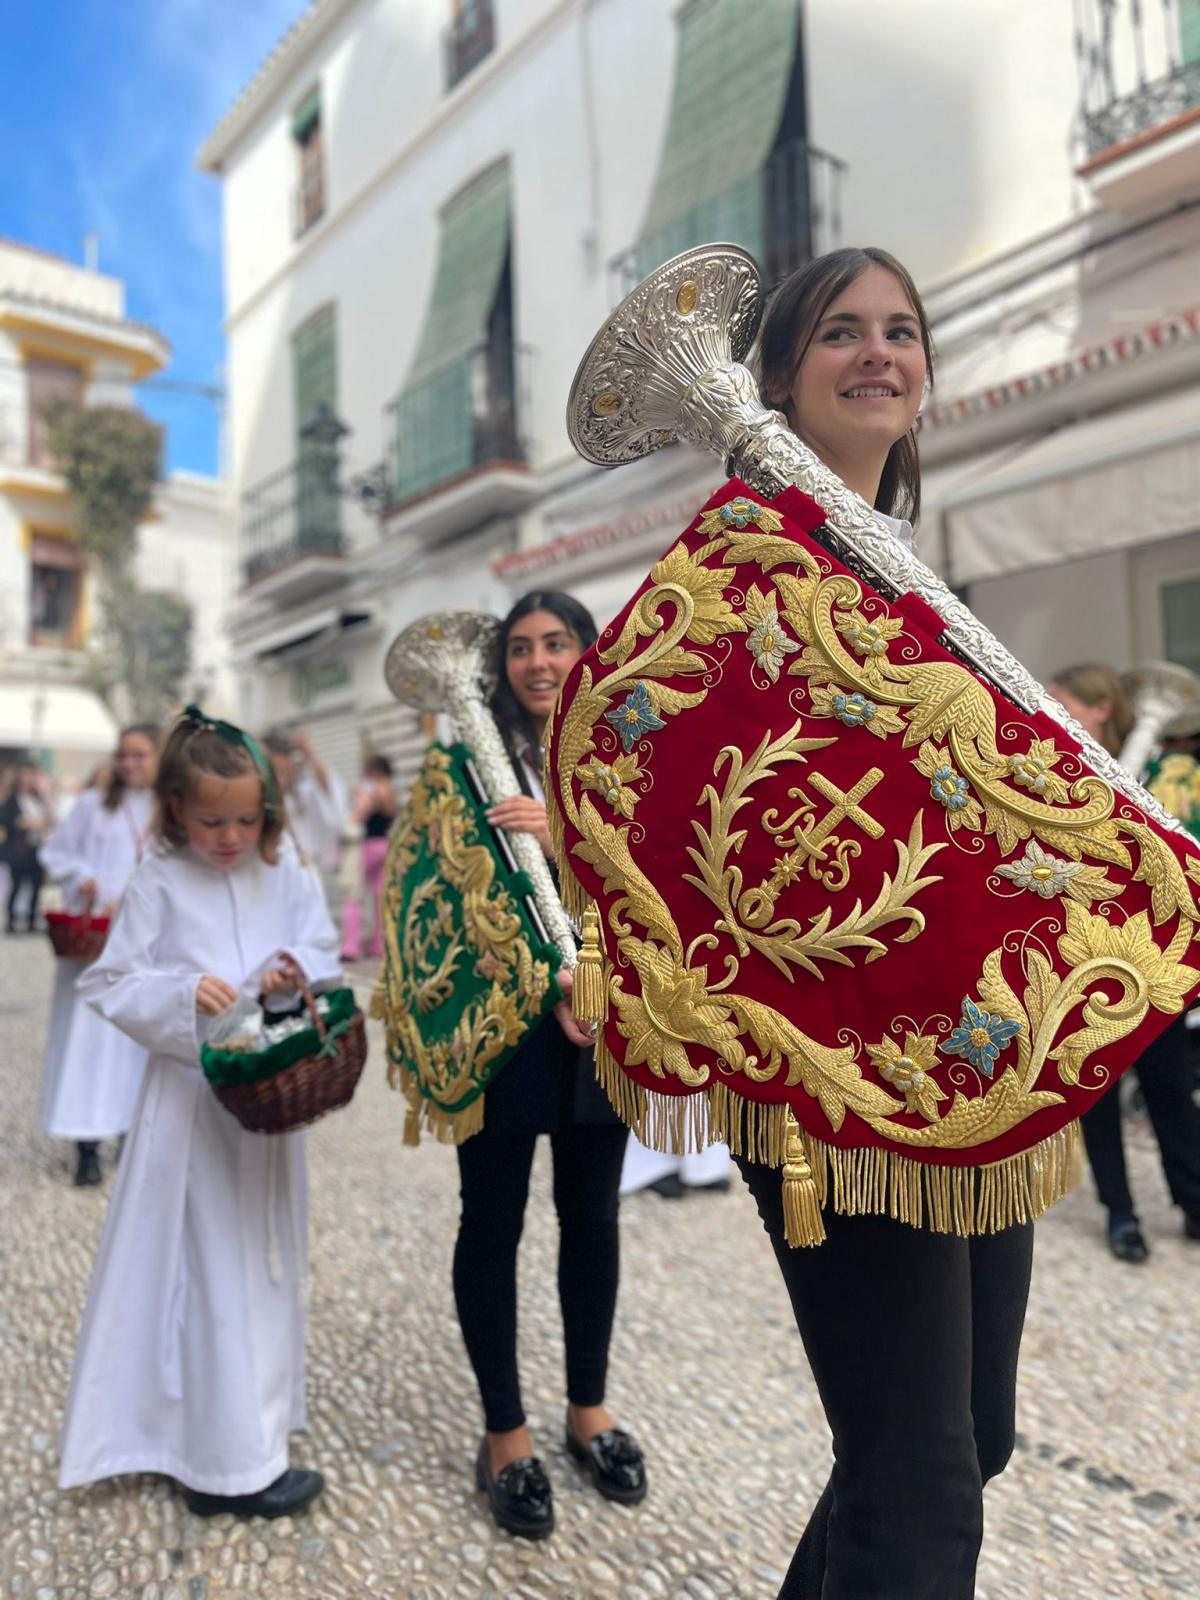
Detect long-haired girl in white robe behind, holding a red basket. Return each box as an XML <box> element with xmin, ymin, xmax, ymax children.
<box><xmin>42</xmin><ymin>723</ymin><xmax>158</xmax><ymax>1187</ymax></box>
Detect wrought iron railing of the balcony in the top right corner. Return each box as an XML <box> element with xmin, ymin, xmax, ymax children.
<box><xmin>1075</xmin><ymin>0</ymin><xmax>1200</xmax><ymax>158</ymax></box>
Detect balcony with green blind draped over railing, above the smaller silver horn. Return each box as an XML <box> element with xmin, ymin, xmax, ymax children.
<box><xmin>384</xmin><ymin>339</ymin><xmax>536</xmax><ymax>538</ymax></box>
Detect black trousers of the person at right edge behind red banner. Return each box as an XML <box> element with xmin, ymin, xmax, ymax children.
<box><xmin>1082</xmin><ymin>1016</ymin><xmax>1200</xmax><ymax>1222</ymax></box>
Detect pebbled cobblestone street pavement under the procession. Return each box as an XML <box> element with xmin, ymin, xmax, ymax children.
<box><xmin>0</xmin><ymin>938</ymin><xmax>1200</xmax><ymax>1600</ymax></box>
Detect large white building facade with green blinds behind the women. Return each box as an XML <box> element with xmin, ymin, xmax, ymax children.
<box><xmin>200</xmin><ymin>0</ymin><xmax>1200</xmax><ymax>790</ymax></box>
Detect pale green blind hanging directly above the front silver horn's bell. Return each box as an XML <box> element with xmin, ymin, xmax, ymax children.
<box><xmin>637</xmin><ymin>0</ymin><xmax>800</xmax><ymax>274</ymax></box>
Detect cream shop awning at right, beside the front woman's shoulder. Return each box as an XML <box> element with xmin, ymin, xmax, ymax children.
<box><xmin>936</xmin><ymin>389</ymin><xmax>1200</xmax><ymax>584</ymax></box>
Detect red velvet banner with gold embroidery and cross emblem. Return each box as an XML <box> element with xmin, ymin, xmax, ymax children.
<box><xmin>547</xmin><ymin>480</ymin><xmax>1200</xmax><ymax>1166</ymax></box>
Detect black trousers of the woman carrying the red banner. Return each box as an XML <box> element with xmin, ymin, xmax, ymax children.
<box><xmin>738</xmin><ymin>1160</ymin><xmax>1034</xmax><ymax>1600</ymax></box>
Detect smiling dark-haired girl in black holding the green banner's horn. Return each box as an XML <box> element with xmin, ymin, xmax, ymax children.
<box><xmin>454</xmin><ymin>594</ymin><xmax>646</xmax><ymax>1539</ymax></box>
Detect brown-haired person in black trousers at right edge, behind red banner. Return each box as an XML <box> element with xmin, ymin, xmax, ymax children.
<box><xmin>1050</xmin><ymin>661</ymin><xmax>1200</xmax><ymax>1264</ymax></box>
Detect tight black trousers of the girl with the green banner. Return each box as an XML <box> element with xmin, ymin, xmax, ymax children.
<box><xmin>454</xmin><ymin>1123</ymin><xmax>627</xmax><ymax>1434</ymax></box>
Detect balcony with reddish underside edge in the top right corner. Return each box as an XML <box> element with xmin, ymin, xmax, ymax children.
<box><xmin>1075</xmin><ymin>0</ymin><xmax>1200</xmax><ymax>211</ymax></box>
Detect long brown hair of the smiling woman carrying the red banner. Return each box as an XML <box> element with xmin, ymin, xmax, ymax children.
<box><xmin>758</xmin><ymin>246</ymin><xmax>933</xmax><ymax>522</ymax></box>
